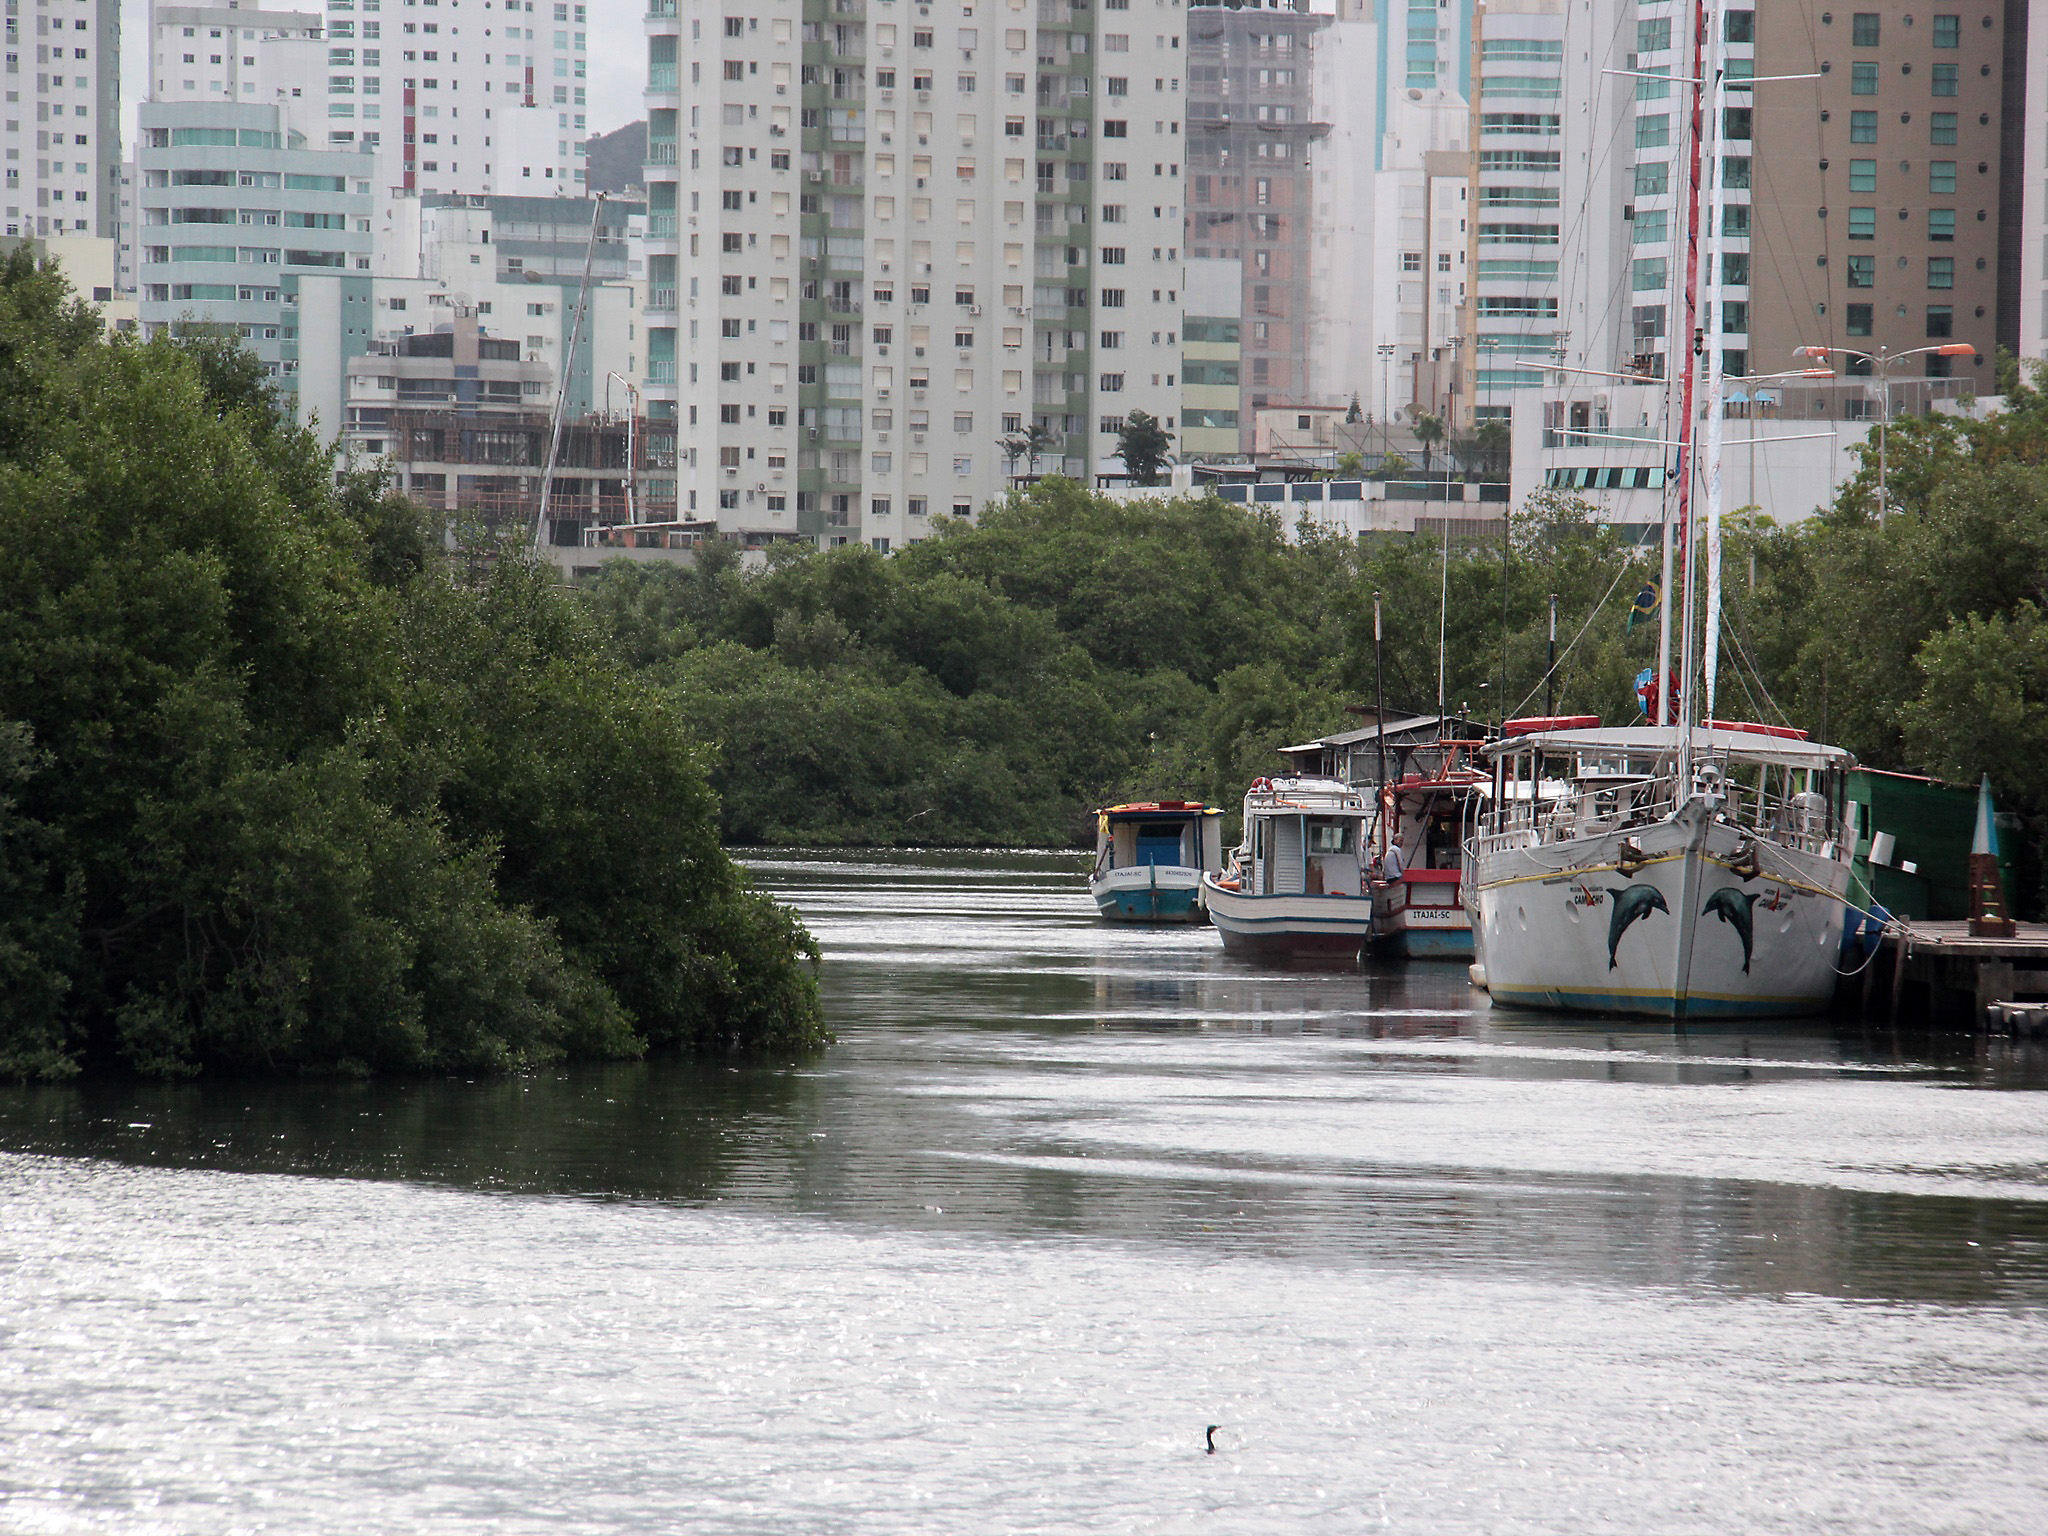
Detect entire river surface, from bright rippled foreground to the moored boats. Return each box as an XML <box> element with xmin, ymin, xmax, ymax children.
<box><xmin>0</xmin><ymin>856</ymin><xmax>2048</xmax><ymax>1534</ymax></box>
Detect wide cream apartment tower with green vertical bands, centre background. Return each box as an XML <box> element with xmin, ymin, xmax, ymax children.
<box><xmin>647</xmin><ymin>0</ymin><xmax>1188</xmax><ymax>549</ymax></box>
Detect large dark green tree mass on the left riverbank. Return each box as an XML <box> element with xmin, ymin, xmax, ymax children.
<box><xmin>0</xmin><ymin>252</ymin><xmax>821</xmax><ymax>1077</ymax></box>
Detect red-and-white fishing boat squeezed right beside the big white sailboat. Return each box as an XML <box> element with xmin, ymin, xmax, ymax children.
<box><xmin>1372</xmin><ymin>741</ymin><xmax>1487</xmax><ymax>961</ymax></box>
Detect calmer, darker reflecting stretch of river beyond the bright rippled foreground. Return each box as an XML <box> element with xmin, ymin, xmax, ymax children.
<box><xmin>0</xmin><ymin>854</ymin><xmax>2048</xmax><ymax>1305</ymax></box>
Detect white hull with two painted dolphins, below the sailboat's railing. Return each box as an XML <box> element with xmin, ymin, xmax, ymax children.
<box><xmin>1475</xmin><ymin>807</ymin><xmax>1849</xmax><ymax>1020</ymax></box>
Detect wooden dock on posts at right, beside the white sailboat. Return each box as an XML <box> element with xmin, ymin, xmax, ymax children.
<box><xmin>1843</xmin><ymin>918</ymin><xmax>2048</xmax><ymax>1032</ymax></box>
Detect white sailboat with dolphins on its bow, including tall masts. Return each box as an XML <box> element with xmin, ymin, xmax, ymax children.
<box><xmin>1466</xmin><ymin>4</ymin><xmax>1853</xmax><ymax>1020</ymax></box>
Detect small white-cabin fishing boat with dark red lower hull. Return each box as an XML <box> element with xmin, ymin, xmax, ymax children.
<box><xmin>1202</xmin><ymin>778</ymin><xmax>1372</xmax><ymax>963</ymax></box>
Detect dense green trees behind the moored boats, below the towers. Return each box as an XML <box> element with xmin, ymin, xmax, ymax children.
<box><xmin>590</xmin><ymin>381</ymin><xmax>2048</xmax><ymax>911</ymax></box>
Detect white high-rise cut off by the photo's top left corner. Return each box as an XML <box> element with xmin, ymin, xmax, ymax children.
<box><xmin>0</xmin><ymin>0</ymin><xmax>121</xmax><ymax>238</ymax></box>
